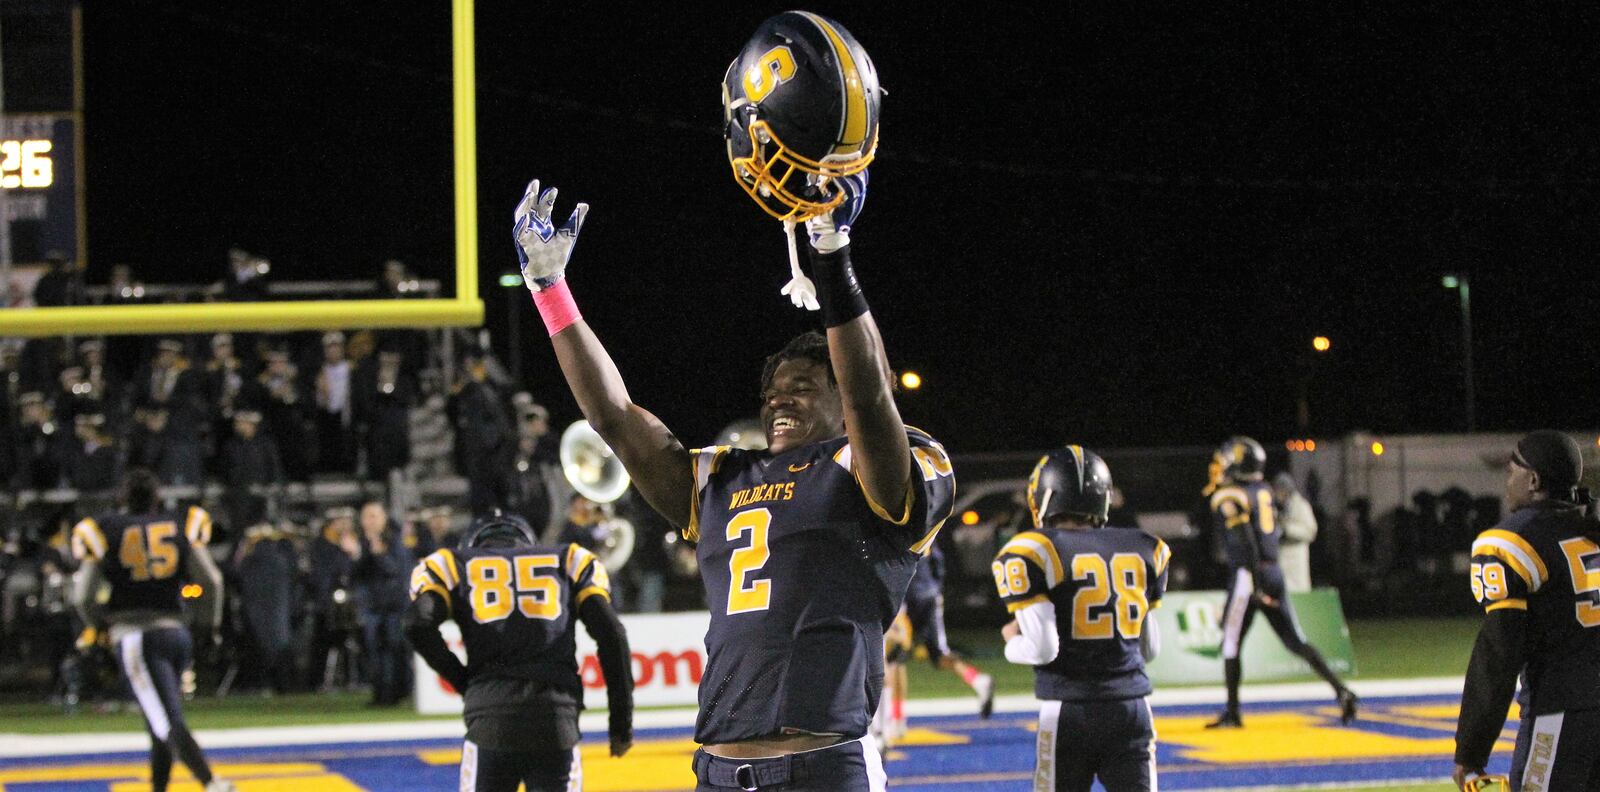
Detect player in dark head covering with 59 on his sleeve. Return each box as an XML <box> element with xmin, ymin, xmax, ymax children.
<box><xmin>1454</xmin><ymin>430</ymin><xmax>1600</xmax><ymax>792</ymax></box>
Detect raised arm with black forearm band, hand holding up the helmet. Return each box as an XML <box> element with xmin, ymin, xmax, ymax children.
<box><xmin>806</xmin><ymin>171</ymin><xmax>910</xmax><ymax>517</ymax></box>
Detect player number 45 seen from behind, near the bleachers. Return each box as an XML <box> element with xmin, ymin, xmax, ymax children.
<box><xmin>72</xmin><ymin>469</ymin><xmax>234</xmax><ymax>792</ymax></box>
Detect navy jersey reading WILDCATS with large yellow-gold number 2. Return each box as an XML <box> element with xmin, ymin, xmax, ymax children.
<box><xmin>683</xmin><ymin>427</ymin><xmax>955</xmax><ymax>744</ymax></box>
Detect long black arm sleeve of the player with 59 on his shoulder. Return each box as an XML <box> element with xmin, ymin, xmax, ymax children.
<box><xmin>1456</xmin><ymin>608</ymin><xmax>1528</xmax><ymax>770</ymax></box>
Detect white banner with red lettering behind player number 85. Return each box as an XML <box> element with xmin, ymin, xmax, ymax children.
<box><xmin>411</xmin><ymin>611</ymin><xmax>710</xmax><ymax>715</ymax></box>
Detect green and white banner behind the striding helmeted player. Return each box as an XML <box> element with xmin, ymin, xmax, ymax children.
<box><xmin>1149</xmin><ymin>589</ymin><xmax>1355</xmax><ymax>688</ymax></box>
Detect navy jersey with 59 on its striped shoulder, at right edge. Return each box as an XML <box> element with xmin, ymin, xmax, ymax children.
<box><xmin>1470</xmin><ymin>501</ymin><xmax>1600</xmax><ymax>715</ymax></box>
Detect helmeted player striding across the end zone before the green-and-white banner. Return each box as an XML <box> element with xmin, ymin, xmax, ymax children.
<box><xmin>1206</xmin><ymin>437</ymin><xmax>1358</xmax><ymax>728</ymax></box>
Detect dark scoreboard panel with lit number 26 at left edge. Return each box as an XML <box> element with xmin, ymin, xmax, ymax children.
<box><xmin>0</xmin><ymin>114</ymin><xmax>83</xmax><ymax>264</ymax></box>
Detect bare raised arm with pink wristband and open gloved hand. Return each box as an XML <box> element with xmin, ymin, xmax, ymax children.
<box><xmin>514</xmin><ymin>179</ymin><xmax>694</xmax><ymax>528</ymax></box>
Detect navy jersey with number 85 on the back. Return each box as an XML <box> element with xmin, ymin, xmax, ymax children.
<box><xmin>411</xmin><ymin>544</ymin><xmax>611</xmax><ymax>710</ymax></box>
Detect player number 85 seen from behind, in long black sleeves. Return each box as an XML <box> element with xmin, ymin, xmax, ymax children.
<box><xmin>405</xmin><ymin>510</ymin><xmax>634</xmax><ymax>792</ymax></box>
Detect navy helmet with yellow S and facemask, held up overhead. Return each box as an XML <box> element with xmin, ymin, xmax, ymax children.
<box><xmin>722</xmin><ymin>11</ymin><xmax>883</xmax><ymax>222</ymax></box>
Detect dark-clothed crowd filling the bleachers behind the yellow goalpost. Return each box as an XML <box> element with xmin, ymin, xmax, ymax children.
<box><xmin>0</xmin><ymin>251</ymin><xmax>666</xmax><ymax>704</ymax></box>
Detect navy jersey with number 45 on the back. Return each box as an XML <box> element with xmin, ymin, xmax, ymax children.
<box><xmin>72</xmin><ymin>506</ymin><xmax>211</xmax><ymax>614</ymax></box>
